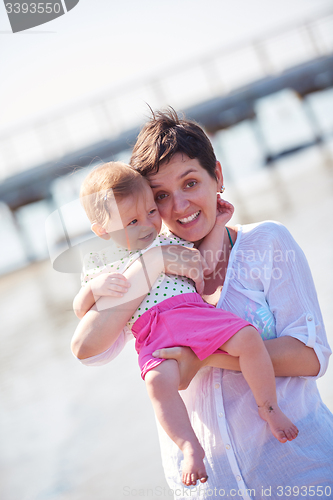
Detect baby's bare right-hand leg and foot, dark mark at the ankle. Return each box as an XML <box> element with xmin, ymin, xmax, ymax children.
<box><xmin>221</xmin><ymin>326</ymin><xmax>298</xmax><ymax>443</ymax></box>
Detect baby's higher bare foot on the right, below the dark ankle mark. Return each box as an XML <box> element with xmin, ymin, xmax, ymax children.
<box><xmin>258</xmin><ymin>402</ymin><xmax>298</xmax><ymax>443</ymax></box>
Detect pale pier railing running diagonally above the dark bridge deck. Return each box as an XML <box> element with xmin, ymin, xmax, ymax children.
<box><xmin>0</xmin><ymin>11</ymin><xmax>333</xmax><ymax>181</ymax></box>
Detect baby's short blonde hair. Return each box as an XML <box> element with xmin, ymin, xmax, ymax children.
<box><xmin>80</xmin><ymin>161</ymin><xmax>146</xmax><ymax>227</ymax></box>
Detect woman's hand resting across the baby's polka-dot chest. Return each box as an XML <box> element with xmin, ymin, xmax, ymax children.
<box><xmin>160</xmin><ymin>245</ymin><xmax>206</xmax><ymax>295</ymax></box>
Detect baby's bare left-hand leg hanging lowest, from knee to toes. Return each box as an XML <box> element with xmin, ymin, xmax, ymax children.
<box><xmin>145</xmin><ymin>359</ymin><xmax>207</xmax><ymax>485</ymax></box>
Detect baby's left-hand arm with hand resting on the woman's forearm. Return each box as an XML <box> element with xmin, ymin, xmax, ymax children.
<box><xmin>73</xmin><ymin>273</ymin><xmax>131</xmax><ymax>319</ymax></box>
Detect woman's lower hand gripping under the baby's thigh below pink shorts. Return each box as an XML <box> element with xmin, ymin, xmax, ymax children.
<box><xmin>153</xmin><ymin>347</ymin><xmax>206</xmax><ymax>391</ymax></box>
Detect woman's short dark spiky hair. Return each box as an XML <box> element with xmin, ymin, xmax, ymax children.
<box><xmin>130</xmin><ymin>108</ymin><xmax>216</xmax><ymax>179</ymax></box>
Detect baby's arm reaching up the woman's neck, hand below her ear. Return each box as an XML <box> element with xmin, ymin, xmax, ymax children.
<box><xmin>198</xmin><ymin>196</ymin><xmax>234</xmax><ymax>276</ymax></box>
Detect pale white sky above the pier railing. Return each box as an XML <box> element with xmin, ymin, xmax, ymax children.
<box><xmin>0</xmin><ymin>0</ymin><xmax>333</xmax><ymax>134</ymax></box>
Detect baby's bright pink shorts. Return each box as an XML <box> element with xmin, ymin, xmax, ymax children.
<box><xmin>132</xmin><ymin>293</ymin><xmax>253</xmax><ymax>379</ymax></box>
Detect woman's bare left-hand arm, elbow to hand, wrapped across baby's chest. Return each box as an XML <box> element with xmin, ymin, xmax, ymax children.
<box><xmin>72</xmin><ymin>245</ymin><xmax>204</xmax><ymax>359</ymax></box>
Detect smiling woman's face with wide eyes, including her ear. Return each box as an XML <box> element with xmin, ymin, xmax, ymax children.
<box><xmin>148</xmin><ymin>153</ymin><xmax>223</xmax><ymax>242</ymax></box>
